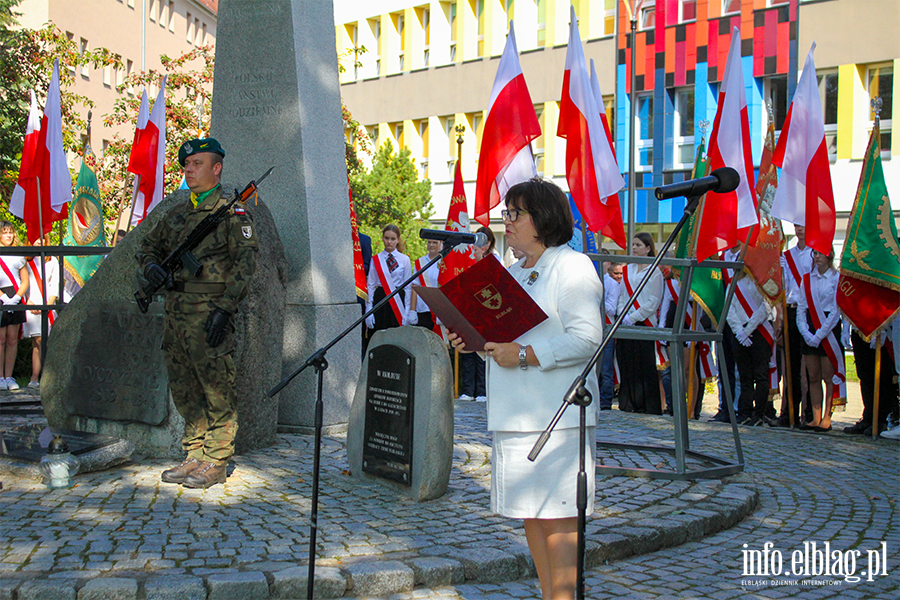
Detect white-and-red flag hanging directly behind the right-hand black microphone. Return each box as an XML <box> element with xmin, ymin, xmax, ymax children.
<box><xmin>697</xmin><ymin>27</ymin><xmax>759</xmax><ymax>261</ymax></box>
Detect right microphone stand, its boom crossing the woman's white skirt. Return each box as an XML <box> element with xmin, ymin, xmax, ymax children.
<box><xmin>528</xmin><ymin>194</ymin><xmax>702</xmax><ymax>600</ymax></box>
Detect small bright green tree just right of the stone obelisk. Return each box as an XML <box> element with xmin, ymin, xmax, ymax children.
<box><xmin>350</xmin><ymin>141</ymin><xmax>433</xmax><ymax>257</ymax></box>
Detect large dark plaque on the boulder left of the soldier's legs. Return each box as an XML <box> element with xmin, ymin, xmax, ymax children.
<box><xmin>65</xmin><ymin>301</ymin><xmax>168</xmax><ymax>425</ymax></box>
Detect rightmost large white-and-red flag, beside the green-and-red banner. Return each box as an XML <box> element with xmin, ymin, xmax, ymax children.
<box><xmin>772</xmin><ymin>44</ymin><xmax>837</xmax><ymax>255</ymax></box>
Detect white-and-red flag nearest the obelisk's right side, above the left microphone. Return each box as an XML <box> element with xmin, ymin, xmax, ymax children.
<box><xmin>472</xmin><ymin>21</ymin><xmax>541</xmax><ymax>227</ymax></box>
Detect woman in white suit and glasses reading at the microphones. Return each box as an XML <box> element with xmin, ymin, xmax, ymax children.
<box><xmin>448</xmin><ymin>178</ymin><xmax>603</xmax><ymax>600</ymax></box>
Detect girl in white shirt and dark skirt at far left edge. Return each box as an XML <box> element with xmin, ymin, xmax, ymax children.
<box><xmin>0</xmin><ymin>221</ymin><xmax>28</xmax><ymax>390</ymax></box>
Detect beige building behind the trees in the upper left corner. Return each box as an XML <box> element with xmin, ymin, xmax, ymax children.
<box><xmin>15</xmin><ymin>0</ymin><xmax>219</xmax><ymax>153</ymax></box>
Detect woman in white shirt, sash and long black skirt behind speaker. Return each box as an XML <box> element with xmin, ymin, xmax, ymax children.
<box><xmin>616</xmin><ymin>232</ymin><xmax>663</xmax><ymax>415</ymax></box>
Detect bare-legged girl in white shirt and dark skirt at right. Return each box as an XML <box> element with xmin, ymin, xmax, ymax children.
<box><xmin>797</xmin><ymin>249</ymin><xmax>843</xmax><ymax>432</ymax></box>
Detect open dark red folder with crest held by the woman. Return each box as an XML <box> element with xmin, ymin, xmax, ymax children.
<box><xmin>412</xmin><ymin>255</ymin><xmax>547</xmax><ymax>351</ymax></box>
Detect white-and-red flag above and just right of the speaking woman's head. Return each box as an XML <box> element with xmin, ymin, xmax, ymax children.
<box><xmin>556</xmin><ymin>7</ymin><xmax>626</xmax><ymax>249</ymax></box>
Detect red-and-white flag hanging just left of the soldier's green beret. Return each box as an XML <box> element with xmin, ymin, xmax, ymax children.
<box><xmin>128</xmin><ymin>77</ymin><xmax>166</xmax><ymax>227</ymax></box>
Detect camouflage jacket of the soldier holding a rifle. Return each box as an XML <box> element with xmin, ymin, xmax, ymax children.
<box><xmin>135</xmin><ymin>187</ymin><xmax>258</xmax><ymax>314</ymax></box>
